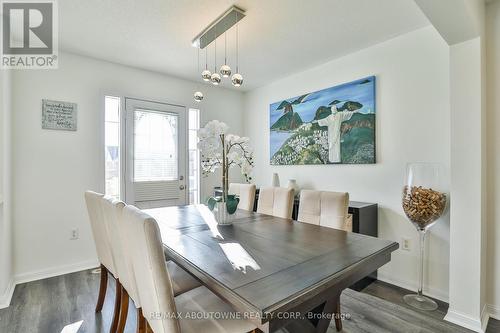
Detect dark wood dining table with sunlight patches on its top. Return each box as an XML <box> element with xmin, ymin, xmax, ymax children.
<box><xmin>144</xmin><ymin>205</ymin><xmax>399</xmax><ymax>333</ymax></box>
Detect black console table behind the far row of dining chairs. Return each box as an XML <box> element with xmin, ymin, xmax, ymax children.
<box><xmin>214</xmin><ymin>188</ymin><xmax>378</xmax><ymax>291</ymax></box>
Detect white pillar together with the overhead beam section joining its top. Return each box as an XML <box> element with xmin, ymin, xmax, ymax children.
<box><xmin>415</xmin><ymin>0</ymin><xmax>488</xmax><ymax>332</ymax></box>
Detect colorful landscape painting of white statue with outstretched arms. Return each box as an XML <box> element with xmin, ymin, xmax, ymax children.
<box><xmin>270</xmin><ymin>76</ymin><xmax>375</xmax><ymax>165</ymax></box>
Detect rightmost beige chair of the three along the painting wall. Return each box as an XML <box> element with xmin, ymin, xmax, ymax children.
<box><xmin>297</xmin><ymin>190</ymin><xmax>352</xmax><ymax>231</ymax></box>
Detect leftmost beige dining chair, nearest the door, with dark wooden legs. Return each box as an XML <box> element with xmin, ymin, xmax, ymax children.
<box><xmin>85</xmin><ymin>191</ymin><xmax>121</xmax><ymax>329</ymax></box>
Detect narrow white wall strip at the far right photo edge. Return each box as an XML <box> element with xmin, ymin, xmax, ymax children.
<box><xmin>486</xmin><ymin>1</ymin><xmax>500</xmax><ymax>320</ymax></box>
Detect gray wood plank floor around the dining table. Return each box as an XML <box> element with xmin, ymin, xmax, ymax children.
<box><xmin>0</xmin><ymin>271</ymin><xmax>500</xmax><ymax>333</ymax></box>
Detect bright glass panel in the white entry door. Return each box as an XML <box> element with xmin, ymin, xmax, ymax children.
<box><xmin>133</xmin><ymin>109</ymin><xmax>178</xmax><ymax>182</ymax></box>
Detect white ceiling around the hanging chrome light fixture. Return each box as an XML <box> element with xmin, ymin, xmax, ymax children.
<box><xmin>58</xmin><ymin>0</ymin><xmax>429</xmax><ymax>90</ymax></box>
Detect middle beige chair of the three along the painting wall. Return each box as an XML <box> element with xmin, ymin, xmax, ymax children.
<box><xmin>257</xmin><ymin>187</ymin><xmax>293</xmax><ymax>219</ymax></box>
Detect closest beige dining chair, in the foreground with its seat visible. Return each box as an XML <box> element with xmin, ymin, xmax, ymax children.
<box><xmin>124</xmin><ymin>206</ymin><xmax>256</xmax><ymax>333</ymax></box>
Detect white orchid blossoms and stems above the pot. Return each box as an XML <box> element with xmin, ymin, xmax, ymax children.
<box><xmin>198</xmin><ymin>120</ymin><xmax>254</xmax><ymax>196</ymax></box>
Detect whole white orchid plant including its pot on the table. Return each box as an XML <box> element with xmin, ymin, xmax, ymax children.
<box><xmin>198</xmin><ymin>120</ymin><xmax>253</xmax><ymax>225</ymax></box>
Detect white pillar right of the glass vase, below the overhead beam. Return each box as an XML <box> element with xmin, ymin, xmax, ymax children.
<box><xmin>446</xmin><ymin>37</ymin><xmax>486</xmax><ymax>330</ymax></box>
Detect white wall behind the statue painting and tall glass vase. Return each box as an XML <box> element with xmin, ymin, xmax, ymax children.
<box><xmin>240</xmin><ymin>27</ymin><xmax>450</xmax><ymax>300</ymax></box>
